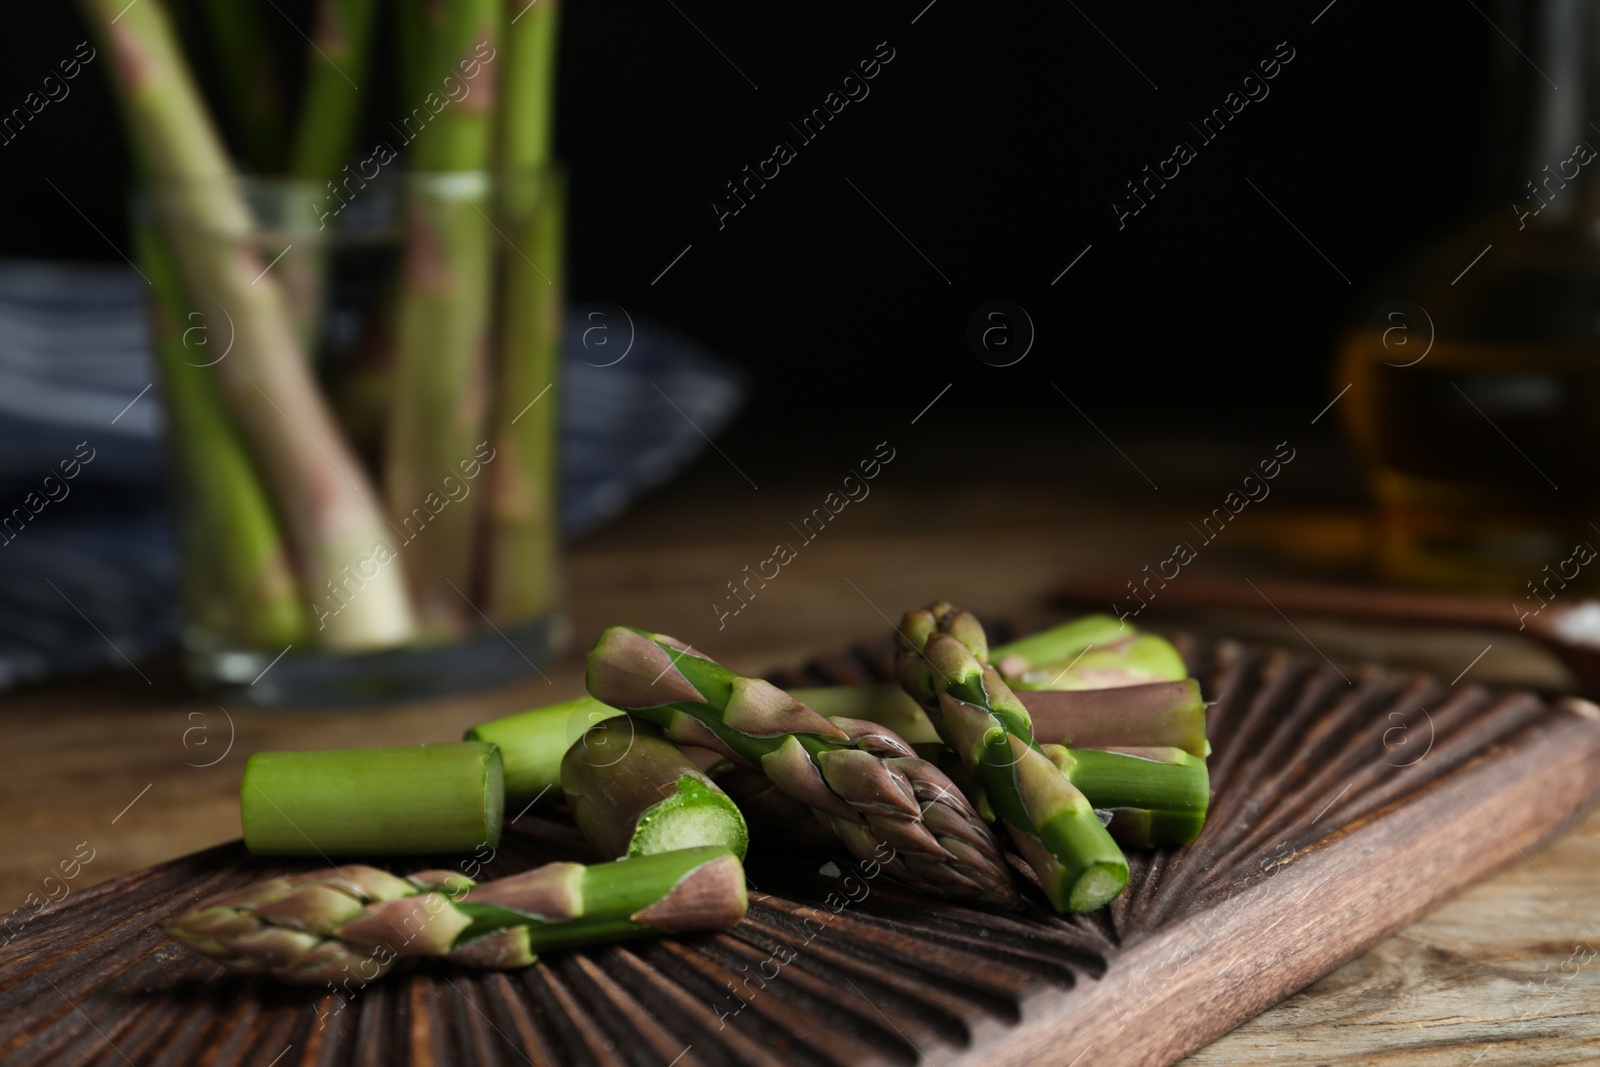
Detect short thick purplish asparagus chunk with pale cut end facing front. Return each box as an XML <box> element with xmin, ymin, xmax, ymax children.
<box><xmin>562</xmin><ymin>715</ymin><xmax>749</xmax><ymax>859</ymax></box>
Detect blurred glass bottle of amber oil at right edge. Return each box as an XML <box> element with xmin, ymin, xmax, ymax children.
<box><xmin>1334</xmin><ymin>0</ymin><xmax>1600</xmax><ymax>595</ymax></box>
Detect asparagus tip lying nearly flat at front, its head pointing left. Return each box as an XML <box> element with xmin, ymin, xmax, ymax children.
<box><xmin>166</xmin><ymin>848</ymin><xmax>747</xmax><ymax>985</ymax></box>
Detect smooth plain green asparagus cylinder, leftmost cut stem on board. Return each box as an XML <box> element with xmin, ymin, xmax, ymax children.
<box><xmin>238</xmin><ymin>741</ymin><xmax>506</xmax><ymax>856</ymax></box>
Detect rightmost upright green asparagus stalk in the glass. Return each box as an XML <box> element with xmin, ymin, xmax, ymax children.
<box><xmin>486</xmin><ymin>0</ymin><xmax>565</xmax><ymax>622</ymax></box>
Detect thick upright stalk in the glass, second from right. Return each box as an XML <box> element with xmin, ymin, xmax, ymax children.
<box><xmin>384</xmin><ymin>0</ymin><xmax>499</xmax><ymax>638</ymax></box>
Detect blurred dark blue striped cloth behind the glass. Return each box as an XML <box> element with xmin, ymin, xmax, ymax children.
<box><xmin>0</xmin><ymin>261</ymin><xmax>744</xmax><ymax>688</ymax></box>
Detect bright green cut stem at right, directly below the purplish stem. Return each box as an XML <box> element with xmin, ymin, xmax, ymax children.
<box><xmin>1043</xmin><ymin>745</ymin><xmax>1211</xmax><ymax>848</ymax></box>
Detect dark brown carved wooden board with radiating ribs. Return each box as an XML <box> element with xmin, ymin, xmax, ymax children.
<box><xmin>0</xmin><ymin>633</ymin><xmax>1600</xmax><ymax>1067</ymax></box>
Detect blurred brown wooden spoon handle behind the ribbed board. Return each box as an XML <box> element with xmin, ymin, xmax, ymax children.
<box><xmin>1054</xmin><ymin>574</ymin><xmax>1518</xmax><ymax>630</ymax></box>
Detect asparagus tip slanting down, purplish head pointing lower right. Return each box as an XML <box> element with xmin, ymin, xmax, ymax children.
<box><xmin>589</xmin><ymin>627</ymin><xmax>1024</xmax><ymax>907</ymax></box>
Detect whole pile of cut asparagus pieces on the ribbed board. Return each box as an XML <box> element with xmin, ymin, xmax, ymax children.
<box><xmin>168</xmin><ymin>603</ymin><xmax>1210</xmax><ymax>984</ymax></box>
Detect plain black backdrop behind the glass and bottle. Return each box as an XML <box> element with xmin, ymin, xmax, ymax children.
<box><xmin>0</xmin><ymin>0</ymin><xmax>1515</xmax><ymax>451</ymax></box>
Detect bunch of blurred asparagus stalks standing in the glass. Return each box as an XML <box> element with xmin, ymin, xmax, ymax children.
<box><xmin>80</xmin><ymin>0</ymin><xmax>562</xmax><ymax>654</ymax></box>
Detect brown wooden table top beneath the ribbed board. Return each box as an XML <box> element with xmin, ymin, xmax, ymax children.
<box><xmin>0</xmin><ymin>470</ymin><xmax>1600</xmax><ymax>1067</ymax></box>
